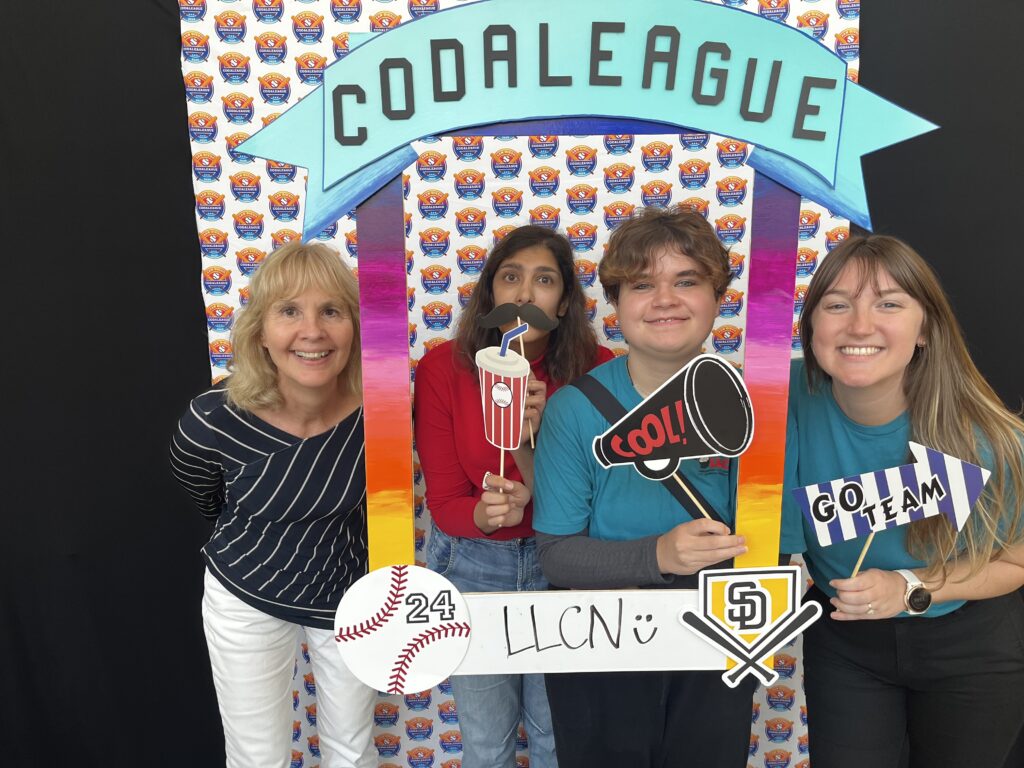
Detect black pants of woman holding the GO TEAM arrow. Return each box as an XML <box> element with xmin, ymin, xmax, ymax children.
<box><xmin>804</xmin><ymin>589</ymin><xmax>1024</xmax><ymax>768</ymax></box>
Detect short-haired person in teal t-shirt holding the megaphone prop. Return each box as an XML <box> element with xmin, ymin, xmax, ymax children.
<box><xmin>534</xmin><ymin>208</ymin><xmax>799</xmax><ymax>768</ymax></box>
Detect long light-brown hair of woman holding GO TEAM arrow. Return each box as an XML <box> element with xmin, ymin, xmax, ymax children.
<box><xmin>800</xmin><ymin>236</ymin><xmax>1024</xmax><ymax>580</ymax></box>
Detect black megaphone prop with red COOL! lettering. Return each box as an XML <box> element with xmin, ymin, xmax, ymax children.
<box><xmin>593</xmin><ymin>354</ymin><xmax>754</xmax><ymax>480</ymax></box>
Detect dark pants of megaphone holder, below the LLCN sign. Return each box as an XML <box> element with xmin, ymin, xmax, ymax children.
<box><xmin>545</xmin><ymin>672</ymin><xmax>757</xmax><ymax>768</ymax></box>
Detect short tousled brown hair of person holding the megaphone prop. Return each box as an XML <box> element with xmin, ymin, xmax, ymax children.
<box><xmin>597</xmin><ymin>206</ymin><xmax>732</xmax><ymax>302</ymax></box>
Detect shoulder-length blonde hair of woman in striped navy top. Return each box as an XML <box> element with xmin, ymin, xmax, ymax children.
<box><xmin>226</xmin><ymin>243</ymin><xmax>362</xmax><ymax>411</ymax></box>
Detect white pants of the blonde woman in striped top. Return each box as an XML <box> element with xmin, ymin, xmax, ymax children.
<box><xmin>203</xmin><ymin>570</ymin><xmax>377</xmax><ymax>768</ymax></box>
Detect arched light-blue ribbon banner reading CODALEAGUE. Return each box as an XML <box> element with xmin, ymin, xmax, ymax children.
<box><xmin>239</xmin><ymin>0</ymin><xmax>936</xmax><ymax>238</ymax></box>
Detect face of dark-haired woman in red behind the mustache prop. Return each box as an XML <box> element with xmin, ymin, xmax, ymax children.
<box><xmin>490</xmin><ymin>246</ymin><xmax>566</xmax><ymax>357</ymax></box>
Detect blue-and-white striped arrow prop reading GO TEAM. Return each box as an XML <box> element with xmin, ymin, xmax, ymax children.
<box><xmin>793</xmin><ymin>442</ymin><xmax>992</xmax><ymax>547</ymax></box>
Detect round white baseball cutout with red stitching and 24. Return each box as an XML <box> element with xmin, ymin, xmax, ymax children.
<box><xmin>335</xmin><ymin>565</ymin><xmax>470</xmax><ymax>693</ymax></box>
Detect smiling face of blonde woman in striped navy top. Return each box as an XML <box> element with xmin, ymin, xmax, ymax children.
<box><xmin>260</xmin><ymin>288</ymin><xmax>353</xmax><ymax>403</ymax></box>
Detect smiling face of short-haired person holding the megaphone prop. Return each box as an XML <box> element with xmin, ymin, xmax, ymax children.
<box><xmin>615</xmin><ymin>246</ymin><xmax>718</xmax><ymax>368</ymax></box>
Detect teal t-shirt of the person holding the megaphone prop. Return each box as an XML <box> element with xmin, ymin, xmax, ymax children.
<box><xmin>534</xmin><ymin>356</ymin><xmax>803</xmax><ymax>553</ymax></box>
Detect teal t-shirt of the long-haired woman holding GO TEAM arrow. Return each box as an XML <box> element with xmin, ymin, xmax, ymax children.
<box><xmin>783</xmin><ymin>360</ymin><xmax>964</xmax><ymax>616</ymax></box>
